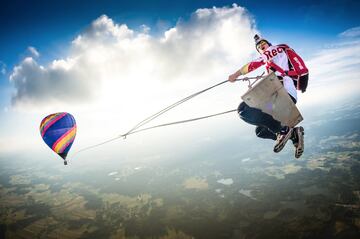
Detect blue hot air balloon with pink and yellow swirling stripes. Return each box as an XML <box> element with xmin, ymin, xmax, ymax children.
<box><xmin>40</xmin><ymin>112</ymin><xmax>76</xmax><ymax>165</ymax></box>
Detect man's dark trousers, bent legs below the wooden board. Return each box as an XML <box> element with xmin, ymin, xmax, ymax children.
<box><xmin>238</xmin><ymin>96</ymin><xmax>296</xmax><ymax>140</ymax></box>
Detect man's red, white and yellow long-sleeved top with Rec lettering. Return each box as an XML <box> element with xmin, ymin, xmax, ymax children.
<box><xmin>240</xmin><ymin>45</ymin><xmax>297</xmax><ymax>100</ymax></box>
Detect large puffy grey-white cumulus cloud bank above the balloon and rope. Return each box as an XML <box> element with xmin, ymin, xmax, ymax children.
<box><xmin>10</xmin><ymin>4</ymin><xmax>256</xmax><ymax>106</ymax></box>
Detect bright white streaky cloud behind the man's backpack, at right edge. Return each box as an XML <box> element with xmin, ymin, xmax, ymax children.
<box><xmin>299</xmin><ymin>39</ymin><xmax>360</xmax><ymax>106</ymax></box>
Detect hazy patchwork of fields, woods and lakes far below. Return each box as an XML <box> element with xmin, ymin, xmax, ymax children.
<box><xmin>0</xmin><ymin>98</ymin><xmax>360</xmax><ymax>238</ymax></box>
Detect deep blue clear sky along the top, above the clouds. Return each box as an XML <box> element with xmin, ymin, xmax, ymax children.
<box><xmin>0</xmin><ymin>0</ymin><xmax>360</xmax><ymax>69</ymax></box>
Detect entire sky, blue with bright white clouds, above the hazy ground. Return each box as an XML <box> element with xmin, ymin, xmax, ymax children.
<box><xmin>0</xmin><ymin>0</ymin><xmax>360</xmax><ymax>162</ymax></box>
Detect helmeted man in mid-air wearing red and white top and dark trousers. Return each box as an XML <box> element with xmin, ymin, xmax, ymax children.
<box><xmin>229</xmin><ymin>35</ymin><xmax>306</xmax><ymax>158</ymax></box>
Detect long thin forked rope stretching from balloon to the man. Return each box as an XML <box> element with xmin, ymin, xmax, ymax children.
<box><xmin>74</xmin><ymin>73</ymin><xmax>264</xmax><ymax>156</ymax></box>
